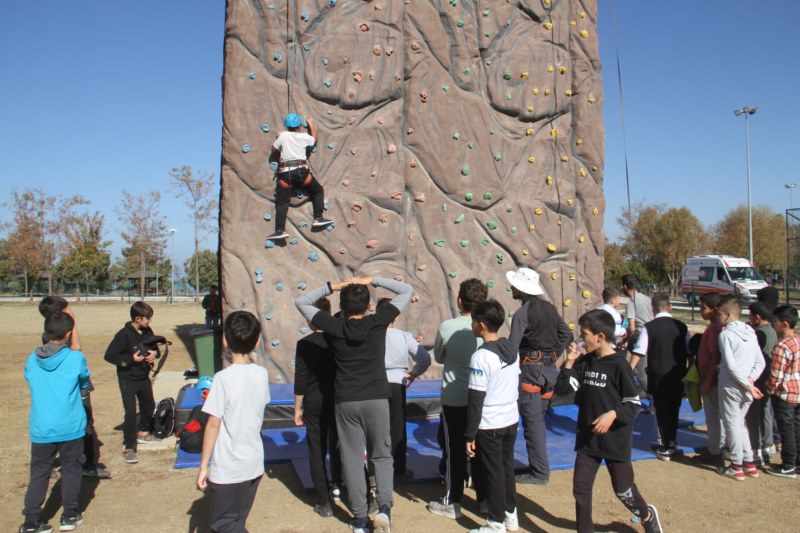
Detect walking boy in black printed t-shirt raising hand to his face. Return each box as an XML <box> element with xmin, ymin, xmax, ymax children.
<box><xmin>555</xmin><ymin>309</ymin><xmax>661</xmax><ymax>533</ymax></box>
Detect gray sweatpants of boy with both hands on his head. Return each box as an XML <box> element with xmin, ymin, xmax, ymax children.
<box><xmin>336</xmin><ymin>399</ymin><xmax>394</xmax><ymax>518</ymax></box>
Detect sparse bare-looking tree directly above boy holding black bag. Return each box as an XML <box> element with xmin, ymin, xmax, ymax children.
<box><xmin>114</xmin><ymin>190</ymin><xmax>167</xmax><ymax>299</ymax></box>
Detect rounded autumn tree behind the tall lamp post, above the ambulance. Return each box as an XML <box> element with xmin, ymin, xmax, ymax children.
<box><xmin>713</xmin><ymin>205</ymin><xmax>786</xmax><ymax>272</ymax></box>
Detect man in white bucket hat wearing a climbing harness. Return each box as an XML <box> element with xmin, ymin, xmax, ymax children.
<box><xmin>506</xmin><ymin>268</ymin><xmax>572</xmax><ymax>485</ymax></box>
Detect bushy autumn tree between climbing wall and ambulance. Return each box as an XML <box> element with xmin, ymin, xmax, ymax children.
<box><xmin>618</xmin><ymin>203</ymin><xmax>709</xmax><ymax>294</ymax></box>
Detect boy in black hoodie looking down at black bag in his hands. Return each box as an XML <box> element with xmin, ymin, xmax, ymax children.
<box><xmin>104</xmin><ymin>302</ymin><xmax>157</xmax><ymax>463</ymax></box>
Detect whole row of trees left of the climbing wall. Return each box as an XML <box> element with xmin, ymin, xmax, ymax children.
<box><xmin>0</xmin><ymin>166</ymin><xmax>219</xmax><ymax>298</ymax></box>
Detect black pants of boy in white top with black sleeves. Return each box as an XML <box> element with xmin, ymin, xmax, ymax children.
<box><xmin>475</xmin><ymin>422</ymin><xmax>517</xmax><ymax>523</ymax></box>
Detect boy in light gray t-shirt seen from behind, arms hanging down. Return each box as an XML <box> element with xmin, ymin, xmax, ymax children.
<box><xmin>197</xmin><ymin>311</ymin><xmax>269</xmax><ymax>531</ymax></box>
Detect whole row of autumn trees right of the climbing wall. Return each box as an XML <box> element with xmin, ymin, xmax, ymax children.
<box><xmin>604</xmin><ymin>202</ymin><xmax>788</xmax><ymax>295</ymax></box>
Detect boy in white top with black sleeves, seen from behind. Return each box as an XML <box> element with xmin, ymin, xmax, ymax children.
<box><xmin>464</xmin><ymin>300</ymin><xmax>520</xmax><ymax>533</ymax></box>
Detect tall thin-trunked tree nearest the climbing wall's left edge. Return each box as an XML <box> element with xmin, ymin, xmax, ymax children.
<box><xmin>169</xmin><ymin>166</ymin><xmax>219</xmax><ymax>302</ymax></box>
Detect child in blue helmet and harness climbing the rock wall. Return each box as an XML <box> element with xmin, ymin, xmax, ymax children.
<box><xmin>268</xmin><ymin>113</ymin><xmax>333</xmax><ymax>240</ymax></box>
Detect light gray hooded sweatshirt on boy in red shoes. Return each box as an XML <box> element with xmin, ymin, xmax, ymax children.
<box><xmin>719</xmin><ymin>321</ymin><xmax>764</xmax><ymax>388</ymax></box>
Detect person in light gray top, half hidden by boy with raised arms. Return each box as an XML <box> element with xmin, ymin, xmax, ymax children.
<box><xmin>375</xmin><ymin>298</ymin><xmax>431</xmax><ymax>484</ymax></box>
